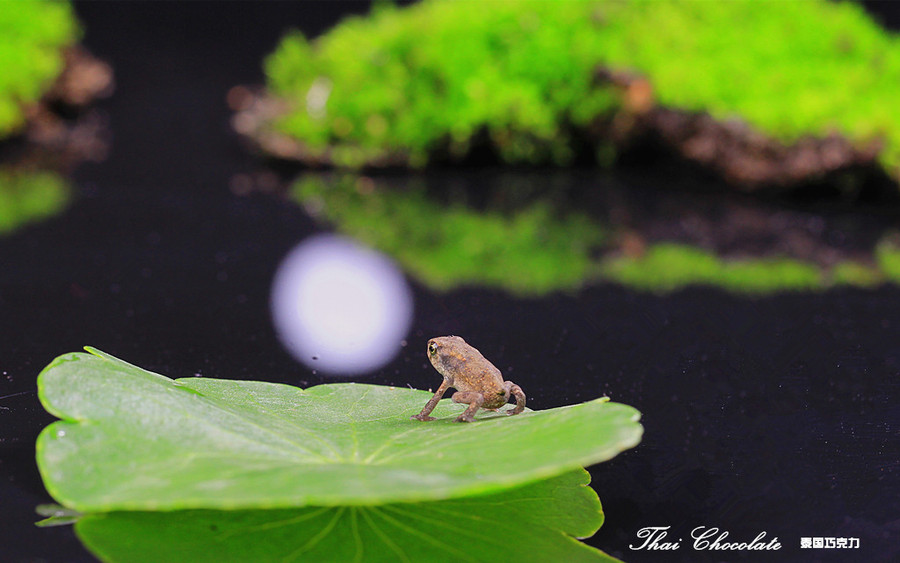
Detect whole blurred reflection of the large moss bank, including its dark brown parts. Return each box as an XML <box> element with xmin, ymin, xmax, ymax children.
<box><xmin>292</xmin><ymin>172</ymin><xmax>900</xmax><ymax>295</ymax></box>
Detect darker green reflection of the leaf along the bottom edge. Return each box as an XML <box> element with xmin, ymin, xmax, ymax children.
<box><xmin>39</xmin><ymin>470</ymin><xmax>615</xmax><ymax>563</ymax></box>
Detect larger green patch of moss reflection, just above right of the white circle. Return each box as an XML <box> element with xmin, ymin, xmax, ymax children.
<box><xmin>293</xmin><ymin>176</ymin><xmax>604</xmax><ymax>295</ymax></box>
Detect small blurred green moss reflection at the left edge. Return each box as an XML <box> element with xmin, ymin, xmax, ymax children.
<box><xmin>0</xmin><ymin>169</ymin><xmax>71</xmax><ymax>236</ymax></box>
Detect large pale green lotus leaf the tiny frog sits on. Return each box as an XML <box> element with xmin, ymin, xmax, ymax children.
<box><xmin>37</xmin><ymin>349</ymin><xmax>642</xmax><ymax>512</ymax></box>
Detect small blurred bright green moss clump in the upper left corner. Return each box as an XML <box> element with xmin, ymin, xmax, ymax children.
<box><xmin>0</xmin><ymin>0</ymin><xmax>80</xmax><ymax>139</ymax></box>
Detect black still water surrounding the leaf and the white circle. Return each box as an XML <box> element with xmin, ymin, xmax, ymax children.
<box><xmin>0</xmin><ymin>2</ymin><xmax>900</xmax><ymax>561</ymax></box>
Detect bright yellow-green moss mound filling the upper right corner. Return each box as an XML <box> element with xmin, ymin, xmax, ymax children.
<box><xmin>602</xmin><ymin>1</ymin><xmax>900</xmax><ymax>171</ymax></box>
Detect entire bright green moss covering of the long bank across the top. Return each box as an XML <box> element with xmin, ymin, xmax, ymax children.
<box><xmin>265</xmin><ymin>0</ymin><xmax>900</xmax><ymax>178</ymax></box>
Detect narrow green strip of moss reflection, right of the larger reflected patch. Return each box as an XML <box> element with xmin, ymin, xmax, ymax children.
<box><xmin>600</xmin><ymin>243</ymin><xmax>824</xmax><ymax>294</ymax></box>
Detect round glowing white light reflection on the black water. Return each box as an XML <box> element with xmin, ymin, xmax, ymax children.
<box><xmin>271</xmin><ymin>235</ymin><xmax>413</xmax><ymax>375</ymax></box>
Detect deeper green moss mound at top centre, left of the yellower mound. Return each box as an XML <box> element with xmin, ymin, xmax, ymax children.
<box><xmin>265</xmin><ymin>2</ymin><xmax>628</xmax><ymax>164</ymax></box>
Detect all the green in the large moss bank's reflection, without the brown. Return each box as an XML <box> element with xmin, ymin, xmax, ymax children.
<box><xmin>291</xmin><ymin>174</ymin><xmax>900</xmax><ymax>296</ymax></box>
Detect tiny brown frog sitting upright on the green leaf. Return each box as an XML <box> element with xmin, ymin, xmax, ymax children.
<box><xmin>411</xmin><ymin>336</ymin><xmax>525</xmax><ymax>422</ymax></box>
